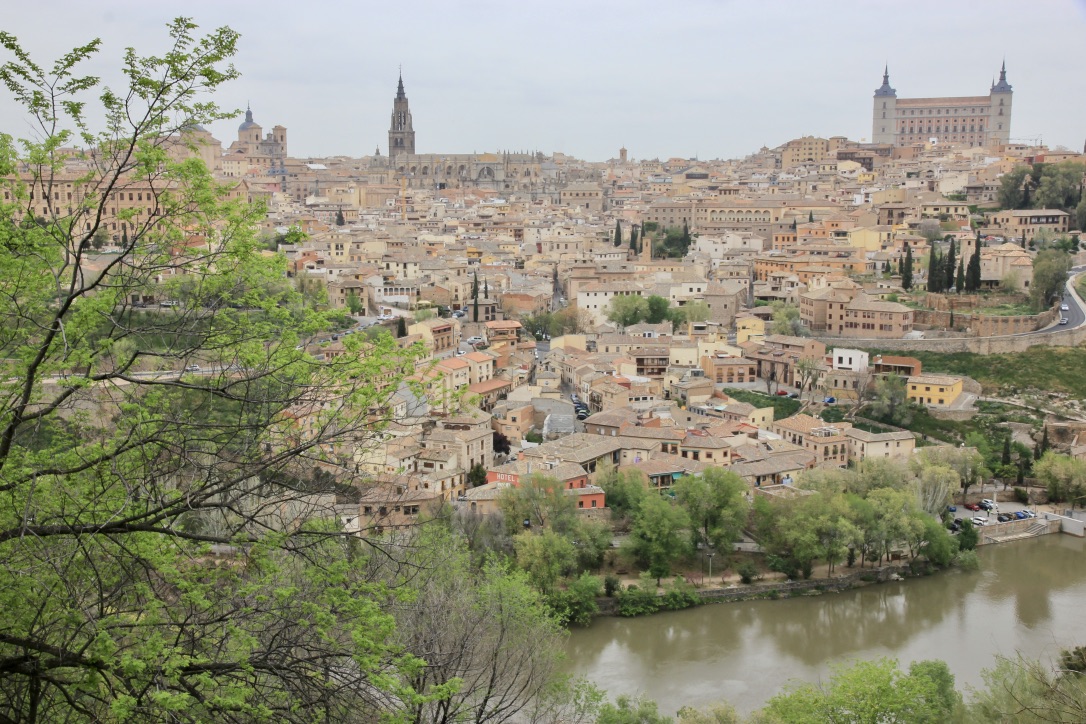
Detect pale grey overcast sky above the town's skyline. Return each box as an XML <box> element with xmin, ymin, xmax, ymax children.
<box><xmin>0</xmin><ymin>0</ymin><xmax>1086</xmax><ymax>161</ymax></box>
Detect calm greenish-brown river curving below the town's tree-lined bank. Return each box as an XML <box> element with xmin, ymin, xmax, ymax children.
<box><xmin>567</xmin><ymin>534</ymin><xmax>1086</xmax><ymax>713</ymax></box>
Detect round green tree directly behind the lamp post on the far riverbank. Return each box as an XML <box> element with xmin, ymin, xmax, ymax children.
<box><xmin>673</xmin><ymin>468</ymin><xmax>749</xmax><ymax>550</ymax></box>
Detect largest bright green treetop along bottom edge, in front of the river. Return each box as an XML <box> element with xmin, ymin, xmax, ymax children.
<box><xmin>761</xmin><ymin>659</ymin><xmax>960</xmax><ymax>724</ymax></box>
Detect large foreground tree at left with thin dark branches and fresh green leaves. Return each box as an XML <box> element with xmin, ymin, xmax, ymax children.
<box><xmin>0</xmin><ymin>18</ymin><xmax>434</xmax><ymax>722</ymax></box>
